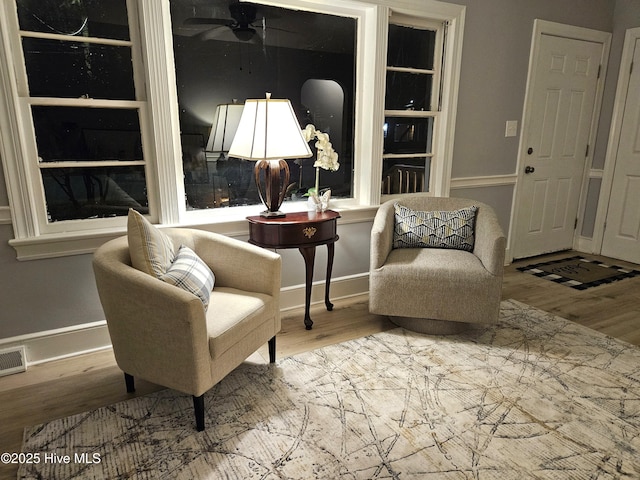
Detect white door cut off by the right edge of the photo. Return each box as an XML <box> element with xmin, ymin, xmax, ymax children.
<box><xmin>602</xmin><ymin>39</ymin><xmax>640</xmax><ymax>263</ymax></box>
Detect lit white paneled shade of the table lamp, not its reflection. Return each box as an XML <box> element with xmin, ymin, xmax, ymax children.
<box><xmin>229</xmin><ymin>94</ymin><xmax>312</xmax><ymax>160</ymax></box>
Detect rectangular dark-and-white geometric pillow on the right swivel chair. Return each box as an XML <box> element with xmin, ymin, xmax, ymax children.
<box><xmin>393</xmin><ymin>203</ymin><xmax>478</xmax><ymax>252</ymax></box>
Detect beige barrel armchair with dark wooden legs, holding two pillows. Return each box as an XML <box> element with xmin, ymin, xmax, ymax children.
<box><xmin>93</xmin><ymin>229</ymin><xmax>281</xmax><ymax>430</ymax></box>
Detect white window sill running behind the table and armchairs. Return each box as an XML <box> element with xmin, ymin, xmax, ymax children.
<box><xmin>9</xmin><ymin>200</ymin><xmax>378</xmax><ymax>260</ymax></box>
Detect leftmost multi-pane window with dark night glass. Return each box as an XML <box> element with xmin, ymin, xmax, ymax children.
<box><xmin>16</xmin><ymin>0</ymin><xmax>148</xmax><ymax>224</ymax></box>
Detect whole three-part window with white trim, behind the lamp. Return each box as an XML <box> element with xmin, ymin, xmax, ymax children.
<box><xmin>0</xmin><ymin>0</ymin><xmax>464</xmax><ymax>258</ymax></box>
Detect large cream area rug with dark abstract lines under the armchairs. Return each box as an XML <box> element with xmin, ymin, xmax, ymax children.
<box><xmin>18</xmin><ymin>300</ymin><xmax>640</xmax><ymax>480</ymax></box>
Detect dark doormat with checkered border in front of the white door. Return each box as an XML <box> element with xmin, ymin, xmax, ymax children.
<box><xmin>517</xmin><ymin>257</ymin><xmax>640</xmax><ymax>290</ymax></box>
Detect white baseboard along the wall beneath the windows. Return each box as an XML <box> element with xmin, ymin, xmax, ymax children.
<box><xmin>0</xmin><ymin>273</ymin><xmax>369</xmax><ymax>367</ymax></box>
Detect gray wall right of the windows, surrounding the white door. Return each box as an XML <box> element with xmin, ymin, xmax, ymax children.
<box><xmin>444</xmin><ymin>0</ymin><xmax>620</xmax><ymax>240</ymax></box>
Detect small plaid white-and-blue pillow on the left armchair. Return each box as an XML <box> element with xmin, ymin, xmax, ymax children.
<box><xmin>160</xmin><ymin>245</ymin><xmax>216</xmax><ymax>310</ymax></box>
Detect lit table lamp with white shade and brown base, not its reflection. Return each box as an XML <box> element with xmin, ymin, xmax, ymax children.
<box><xmin>229</xmin><ymin>93</ymin><xmax>312</xmax><ymax>217</ymax></box>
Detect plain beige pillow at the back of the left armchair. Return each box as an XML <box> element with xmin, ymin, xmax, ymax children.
<box><xmin>127</xmin><ymin>208</ymin><xmax>175</xmax><ymax>278</ymax></box>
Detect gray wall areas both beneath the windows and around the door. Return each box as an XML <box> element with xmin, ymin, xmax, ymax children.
<box><xmin>0</xmin><ymin>0</ymin><xmax>640</xmax><ymax>339</ymax></box>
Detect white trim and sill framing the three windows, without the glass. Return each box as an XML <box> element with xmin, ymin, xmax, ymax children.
<box><xmin>0</xmin><ymin>0</ymin><xmax>466</xmax><ymax>259</ymax></box>
